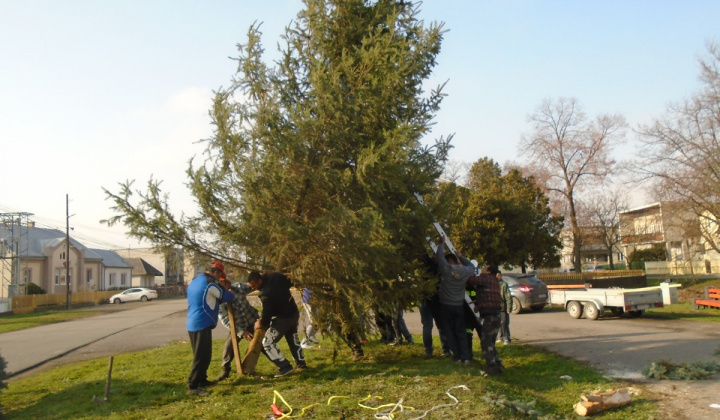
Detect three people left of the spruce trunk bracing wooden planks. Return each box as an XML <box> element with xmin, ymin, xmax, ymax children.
<box><xmin>187</xmin><ymin>261</ymin><xmax>307</xmax><ymax>395</ymax></box>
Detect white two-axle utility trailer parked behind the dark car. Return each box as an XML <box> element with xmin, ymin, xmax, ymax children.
<box><xmin>549</xmin><ymin>285</ymin><xmax>679</xmax><ymax>321</ymax></box>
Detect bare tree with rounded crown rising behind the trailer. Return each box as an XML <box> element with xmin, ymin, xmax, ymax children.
<box><xmin>520</xmin><ymin>98</ymin><xmax>627</xmax><ymax>271</ymax></box>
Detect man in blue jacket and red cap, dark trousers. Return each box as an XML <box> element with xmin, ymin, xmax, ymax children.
<box><xmin>187</xmin><ymin>261</ymin><xmax>234</xmax><ymax>395</ymax></box>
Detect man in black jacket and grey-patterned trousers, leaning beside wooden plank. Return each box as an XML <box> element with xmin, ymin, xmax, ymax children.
<box><xmin>247</xmin><ymin>271</ymin><xmax>307</xmax><ymax>377</ymax></box>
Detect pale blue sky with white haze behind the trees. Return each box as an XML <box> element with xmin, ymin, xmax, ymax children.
<box><xmin>0</xmin><ymin>0</ymin><xmax>720</xmax><ymax>248</ymax></box>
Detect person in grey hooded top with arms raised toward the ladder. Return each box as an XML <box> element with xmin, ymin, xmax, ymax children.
<box><xmin>435</xmin><ymin>236</ymin><xmax>475</xmax><ymax>364</ymax></box>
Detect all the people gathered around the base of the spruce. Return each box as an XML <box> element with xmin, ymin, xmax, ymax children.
<box><xmin>187</xmin><ymin>244</ymin><xmax>513</xmax><ymax>395</ymax></box>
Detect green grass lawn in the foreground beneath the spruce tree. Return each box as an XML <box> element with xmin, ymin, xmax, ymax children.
<box><xmin>0</xmin><ymin>337</ymin><xmax>659</xmax><ymax>420</ymax></box>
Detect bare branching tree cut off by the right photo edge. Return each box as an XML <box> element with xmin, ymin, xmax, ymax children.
<box><xmin>634</xmin><ymin>43</ymin><xmax>720</xmax><ymax>252</ymax></box>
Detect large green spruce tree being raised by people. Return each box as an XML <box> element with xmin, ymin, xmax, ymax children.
<box><xmin>106</xmin><ymin>0</ymin><xmax>449</xmax><ymax>333</ymax></box>
